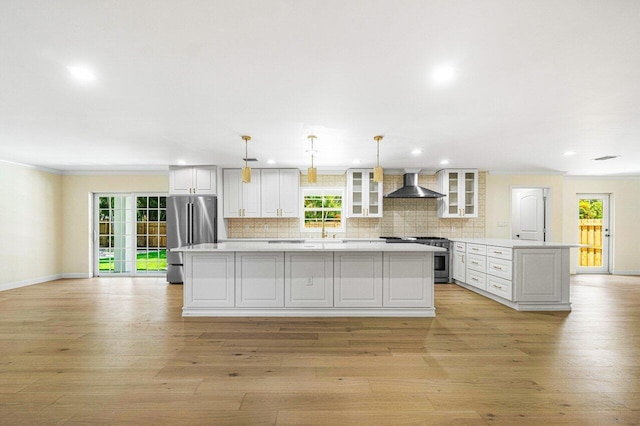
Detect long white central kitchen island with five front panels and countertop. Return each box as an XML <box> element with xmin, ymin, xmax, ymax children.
<box><xmin>174</xmin><ymin>241</ymin><xmax>444</xmax><ymax>317</ymax></box>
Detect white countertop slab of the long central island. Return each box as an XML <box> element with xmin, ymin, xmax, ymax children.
<box><xmin>171</xmin><ymin>240</ymin><xmax>446</xmax><ymax>253</ymax></box>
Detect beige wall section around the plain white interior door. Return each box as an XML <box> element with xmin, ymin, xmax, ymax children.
<box><xmin>486</xmin><ymin>173</ymin><xmax>564</xmax><ymax>242</ymax></box>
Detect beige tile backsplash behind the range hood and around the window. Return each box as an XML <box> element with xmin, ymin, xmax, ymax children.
<box><xmin>227</xmin><ymin>172</ymin><xmax>486</xmax><ymax>238</ymax></box>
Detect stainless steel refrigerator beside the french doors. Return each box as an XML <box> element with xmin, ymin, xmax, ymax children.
<box><xmin>167</xmin><ymin>195</ymin><xmax>218</xmax><ymax>283</ymax></box>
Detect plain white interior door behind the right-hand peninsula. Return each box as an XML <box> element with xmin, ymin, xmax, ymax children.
<box><xmin>511</xmin><ymin>188</ymin><xmax>547</xmax><ymax>241</ymax></box>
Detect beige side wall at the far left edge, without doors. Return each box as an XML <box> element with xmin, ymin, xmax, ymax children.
<box><xmin>0</xmin><ymin>162</ymin><xmax>62</xmax><ymax>289</ymax></box>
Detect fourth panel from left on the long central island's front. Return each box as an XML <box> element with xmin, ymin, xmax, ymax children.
<box><xmin>333</xmin><ymin>252</ymin><xmax>382</xmax><ymax>308</ymax></box>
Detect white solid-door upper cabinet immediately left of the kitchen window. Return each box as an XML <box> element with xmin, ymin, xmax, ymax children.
<box><xmin>260</xmin><ymin>169</ymin><xmax>300</xmax><ymax>218</ymax></box>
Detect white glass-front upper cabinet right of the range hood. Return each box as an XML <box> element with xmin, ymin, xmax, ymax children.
<box><xmin>438</xmin><ymin>169</ymin><xmax>478</xmax><ymax>218</ymax></box>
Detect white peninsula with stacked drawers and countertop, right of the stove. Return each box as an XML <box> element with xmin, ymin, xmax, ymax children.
<box><xmin>451</xmin><ymin>238</ymin><xmax>579</xmax><ymax>311</ymax></box>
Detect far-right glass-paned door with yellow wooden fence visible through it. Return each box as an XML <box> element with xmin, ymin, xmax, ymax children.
<box><xmin>576</xmin><ymin>194</ymin><xmax>611</xmax><ymax>274</ymax></box>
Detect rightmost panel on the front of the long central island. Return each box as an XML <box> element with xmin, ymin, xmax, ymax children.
<box><xmin>382</xmin><ymin>252</ymin><xmax>434</xmax><ymax>308</ymax></box>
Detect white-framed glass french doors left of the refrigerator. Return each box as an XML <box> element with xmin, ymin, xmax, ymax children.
<box><xmin>93</xmin><ymin>193</ymin><xmax>167</xmax><ymax>276</ymax></box>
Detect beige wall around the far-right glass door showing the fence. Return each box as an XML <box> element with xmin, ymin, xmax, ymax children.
<box><xmin>562</xmin><ymin>178</ymin><xmax>640</xmax><ymax>274</ymax></box>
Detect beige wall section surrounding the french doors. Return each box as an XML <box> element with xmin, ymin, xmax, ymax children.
<box><xmin>62</xmin><ymin>174</ymin><xmax>169</xmax><ymax>277</ymax></box>
